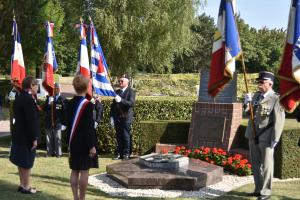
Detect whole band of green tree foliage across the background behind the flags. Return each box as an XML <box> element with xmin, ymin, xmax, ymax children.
<box><xmin>0</xmin><ymin>0</ymin><xmax>286</xmax><ymax>75</ymax></box>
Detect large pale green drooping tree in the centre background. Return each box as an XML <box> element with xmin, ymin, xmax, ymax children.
<box><xmin>94</xmin><ymin>0</ymin><xmax>200</xmax><ymax>74</ymax></box>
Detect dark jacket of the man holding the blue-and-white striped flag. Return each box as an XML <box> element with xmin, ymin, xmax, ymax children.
<box><xmin>110</xmin><ymin>87</ymin><xmax>135</xmax><ymax>123</ymax></box>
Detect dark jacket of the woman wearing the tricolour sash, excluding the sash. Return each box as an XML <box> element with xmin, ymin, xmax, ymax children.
<box><xmin>67</xmin><ymin>96</ymin><xmax>97</xmax><ymax>155</ymax></box>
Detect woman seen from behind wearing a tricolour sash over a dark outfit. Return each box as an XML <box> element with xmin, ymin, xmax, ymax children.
<box><xmin>67</xmin><ymin>75</ymin><xmax>99</xmax><ymax>200</ymax></box>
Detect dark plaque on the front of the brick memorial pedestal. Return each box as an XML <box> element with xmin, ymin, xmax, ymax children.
<box><xmin>188</xmin><ymin>116</ymin><xmax>226</xmax><ymax>147</ymax></box>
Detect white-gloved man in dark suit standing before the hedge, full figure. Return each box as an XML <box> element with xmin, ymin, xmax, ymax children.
<box><xmin>110</xmin><ymin>74</ymin><xmax>135</xmax><ymax>160</ymax></box>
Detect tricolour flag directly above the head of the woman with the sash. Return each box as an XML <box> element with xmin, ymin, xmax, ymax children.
<box><xmin>77</xmin><ymin>22</ymin><xmax>92</xmax><ymax>99</ymax></box>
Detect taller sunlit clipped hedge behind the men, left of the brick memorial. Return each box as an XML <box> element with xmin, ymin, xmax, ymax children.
<box><xmin>11</xmin><ymin>97</ymin><xmax>196</xmax><ymax>154</ymax></box>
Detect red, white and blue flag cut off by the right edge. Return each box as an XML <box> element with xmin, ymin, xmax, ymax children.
<box><xmin>278</xmin><ymin>0</ymin><xmax>300</xmax><ymax>113</ymax></box>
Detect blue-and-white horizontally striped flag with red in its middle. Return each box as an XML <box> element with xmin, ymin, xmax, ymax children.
<box><xmin>90</xmin><ymin>21</ymin><xmax>116</xmax><ymax>96</ymax></box>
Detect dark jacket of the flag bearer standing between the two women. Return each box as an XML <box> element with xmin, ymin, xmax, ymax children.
<box><xmin>43</xmin><ymin>95</ymin><xmax>66</xmax><ymax>129</ymax></box>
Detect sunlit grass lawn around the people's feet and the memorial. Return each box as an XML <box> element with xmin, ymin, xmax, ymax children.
<box><xmin>0</xmin><ymin>137</ymin><xmax>300</xmax><ymax>200</ymax></box>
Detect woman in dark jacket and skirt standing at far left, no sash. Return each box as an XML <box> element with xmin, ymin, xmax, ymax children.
<box><xmin>10</xmin><ymin>76</ymin><xmax>40</xmax><ymax>194</ymax></box>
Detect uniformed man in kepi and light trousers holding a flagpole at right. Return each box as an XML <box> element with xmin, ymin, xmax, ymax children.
<box><xmin>244</xmin><ymin>71</ymin><xmax>285</xmax><ymax>200</ymax></box>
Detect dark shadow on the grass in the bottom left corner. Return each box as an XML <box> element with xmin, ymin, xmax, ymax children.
<box><xmin>0</xmin><ymin>180</ymin><xmax>62</xmax><ymax>200</ymax></box>
